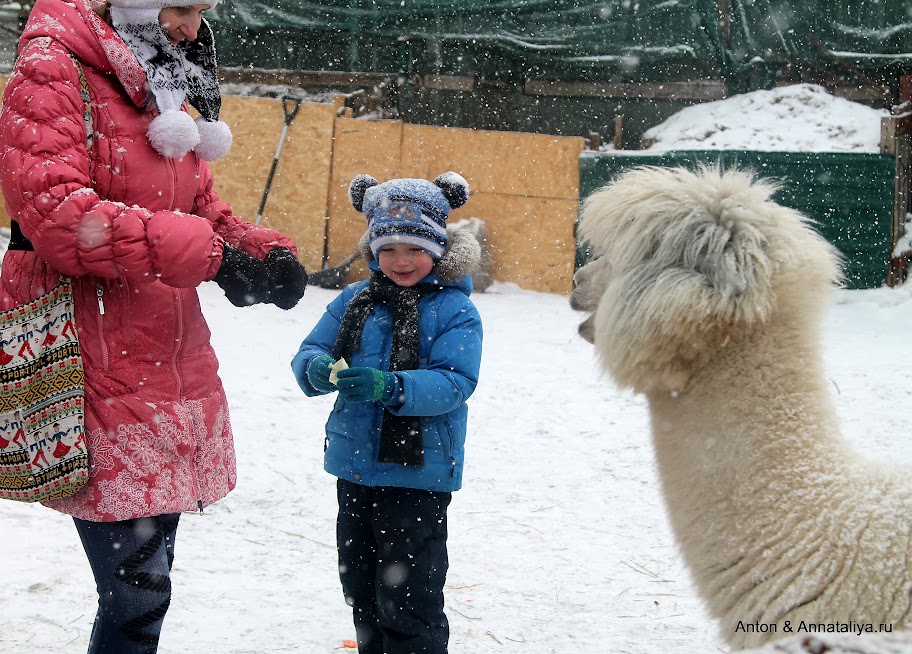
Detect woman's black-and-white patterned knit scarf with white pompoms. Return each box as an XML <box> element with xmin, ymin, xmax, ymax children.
<box><xmin>108</xmin><ymin>0</ymin><xmax>232</xmax><ymax>161</ymax></box>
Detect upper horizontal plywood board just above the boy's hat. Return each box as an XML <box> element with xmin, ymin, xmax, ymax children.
<box><xmin>401</xmin><ymin>125</ymin><xmax>585</xmax><ymax>200</ymax></box>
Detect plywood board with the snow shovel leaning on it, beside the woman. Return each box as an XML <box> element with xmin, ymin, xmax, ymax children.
<box><xmin>212</xmin><ymin>96</ymin><xmax>335</xmax><ymax>269</ymax></box>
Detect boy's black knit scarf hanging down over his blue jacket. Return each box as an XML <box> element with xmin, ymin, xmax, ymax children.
<box><xmin>332</xmin><ymin>271</ymin><xmax>440</xmax><ymax>467</ymax></box>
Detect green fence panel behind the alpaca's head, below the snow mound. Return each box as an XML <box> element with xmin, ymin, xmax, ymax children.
<box><xmin>577</xmin><ymin>150</ymin><xmax>896</xmax><ymax>289</ymax></box>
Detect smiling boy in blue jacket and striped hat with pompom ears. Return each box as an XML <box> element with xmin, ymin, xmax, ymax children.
<box><xmin>291</xmin><ymin>172</ymin><xmax>482</xmax><ymax>654</ymax></box>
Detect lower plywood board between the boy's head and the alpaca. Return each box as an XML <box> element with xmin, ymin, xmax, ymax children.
<box><xmin>464</xmin><ymin>193</ymin><xmax>579</xmax><ymax>293</ymax></box>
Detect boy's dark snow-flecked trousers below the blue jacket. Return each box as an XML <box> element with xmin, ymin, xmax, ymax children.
<box><xmin>336</xmin><ymin>479</ymin><xmax>452</xmax><ymax>654</ymax></box>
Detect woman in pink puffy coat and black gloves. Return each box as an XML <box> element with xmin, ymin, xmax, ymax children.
<box><xmin>0</xmin><ymin>0</ymin><xmax>307</xmax><ymax>654</ymax></box>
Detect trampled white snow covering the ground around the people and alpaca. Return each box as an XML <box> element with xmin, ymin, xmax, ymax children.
<box><xmin>0</xmin><ymin>84</ymin><xmax>912</xmax><ymax>654</ymax></box>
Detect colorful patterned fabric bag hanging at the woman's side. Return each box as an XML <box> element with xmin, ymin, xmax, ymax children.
<box><xmin>0</xmin><ymin>277</ymin><xmax>89</xmax><ymax>502</ymax></box>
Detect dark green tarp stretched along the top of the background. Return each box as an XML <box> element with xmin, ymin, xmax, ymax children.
<box><xmin>211</xmin><ymin>0</ymin><xmax>912</xmax><ymax>91</ymax></box>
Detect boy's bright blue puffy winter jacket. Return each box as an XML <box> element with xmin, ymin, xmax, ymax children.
<box><xmin>291</xmin><ymin>261</ymin><xmax>482</xmax><ymax>491</ymax></box>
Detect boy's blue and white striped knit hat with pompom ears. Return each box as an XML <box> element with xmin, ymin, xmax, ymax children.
<box><xmin>348</xmin><ymin>172</ymin><xmax>469</xmax><ymax>261</ymax></box>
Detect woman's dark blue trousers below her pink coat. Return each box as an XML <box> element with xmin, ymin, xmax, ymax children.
<box><xmin>73</xmin><ymin>513</ymin><xmax>180</xmax><ymax>654</ymax></box>
